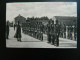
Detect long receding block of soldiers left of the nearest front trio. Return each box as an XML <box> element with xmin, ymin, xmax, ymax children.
<box><xmin>22</xmin><ymin>21</ymin><xmax>44</xmax><ymax>41</ymax></box>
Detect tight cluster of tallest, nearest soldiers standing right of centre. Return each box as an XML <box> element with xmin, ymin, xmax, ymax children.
<box><xmin>47</xmin><ymin>20</ymin><xmax>60</xmax><ymax>46</ymax></box>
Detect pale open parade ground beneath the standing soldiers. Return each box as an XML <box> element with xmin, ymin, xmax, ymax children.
<box><xmin>6</xmin><ymin>28</ymin><xmax>77</xmax><ymax>48</ymax></box>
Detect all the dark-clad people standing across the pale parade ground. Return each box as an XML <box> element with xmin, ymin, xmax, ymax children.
<box><xmin>6</xmin><ymin>20</ymin><xmax>77</xmax><ymax>46</ymax></box>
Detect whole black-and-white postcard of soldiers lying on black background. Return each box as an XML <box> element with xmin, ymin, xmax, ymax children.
<box><xmin>5</xmin><ymin>2</ymin><xmax>77</xmax><ymax>49</ymax></box>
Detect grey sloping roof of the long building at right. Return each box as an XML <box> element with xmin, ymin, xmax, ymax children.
<box><xmin>54</xmin><ymin>16</ymin><xmax>77</xmax><ymax>25</ymax></box>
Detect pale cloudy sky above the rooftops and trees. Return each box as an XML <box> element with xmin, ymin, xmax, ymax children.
<box><xmin>6</xmin><ymin>2</ymin><xmax>77</xmax><ymax>21</ymax></box>
